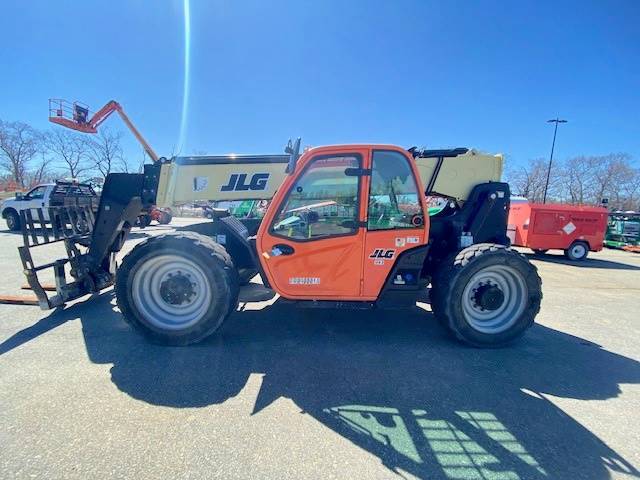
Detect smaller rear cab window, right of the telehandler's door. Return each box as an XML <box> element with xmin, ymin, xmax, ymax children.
<box><xmin>367</xmin><ymin>150</ymin><xmax>422</xmax><ymax>230</ymax></box>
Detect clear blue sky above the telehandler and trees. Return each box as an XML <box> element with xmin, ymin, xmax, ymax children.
<box><xmin>0</xmin><ymin>0</ymin><xmax>640</xmax><ymax>169</ymax></box>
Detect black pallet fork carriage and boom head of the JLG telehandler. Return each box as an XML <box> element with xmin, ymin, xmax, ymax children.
<box><xmin>18</xmin><ymin>169</ymin><xmax>159</xmax><ymax>310</ymax></box>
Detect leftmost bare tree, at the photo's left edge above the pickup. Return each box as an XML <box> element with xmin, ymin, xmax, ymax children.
<box><xmin>0</xmin><ymin>120</ymin><xmax>42</xmax><ymax>188</ymax></box>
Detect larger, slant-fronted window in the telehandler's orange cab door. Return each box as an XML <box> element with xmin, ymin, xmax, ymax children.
<box><xmin>270</xmin><ymin>154</ymin><xmax>362</xmax><ymax>241</ymax></box>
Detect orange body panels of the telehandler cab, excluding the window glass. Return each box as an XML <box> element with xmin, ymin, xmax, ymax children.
<box><xmin>257</xmin><ymin>145</ymin><xmax>429</xmax><ymax>301</ymax></box>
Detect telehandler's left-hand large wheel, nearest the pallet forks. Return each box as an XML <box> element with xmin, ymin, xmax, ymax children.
<box><xmin>115</xmin><ymin>232</ymin><xmax>238</xmax><ymax>345</ymax></box>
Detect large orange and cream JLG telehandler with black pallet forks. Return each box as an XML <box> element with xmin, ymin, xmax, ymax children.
<box><xmin>10</xmin><ymin>102</ymin><xmax>542</xmax><ymax>346</ymax></box>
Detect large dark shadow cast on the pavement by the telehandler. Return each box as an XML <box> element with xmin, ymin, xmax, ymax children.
<box><xmin>0</xmin><ymin>292</ymin><xmax>640</xmax><ymax>479</ymax></box>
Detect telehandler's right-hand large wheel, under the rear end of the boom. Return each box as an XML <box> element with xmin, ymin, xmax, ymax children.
<box><xmin>432</xmin><ymin>243</ymin><xmax>542</xmax><ymax>347</ymax></box>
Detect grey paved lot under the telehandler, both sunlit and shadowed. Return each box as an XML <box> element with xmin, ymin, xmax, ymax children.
<box><xmin>0</xmin><ymin>219</ymin><xmax>640</xmax><ymax>479</ymax></box>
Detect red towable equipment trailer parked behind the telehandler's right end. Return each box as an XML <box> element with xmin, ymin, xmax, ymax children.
<box><xmin>507</xmin><ymin>199</ymin><xmax>608</xmax><ymax>260</ymax></box>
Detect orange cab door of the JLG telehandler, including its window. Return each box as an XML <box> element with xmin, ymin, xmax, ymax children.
<box><xmin>258</xmin><ymin>147</ymin><xmax>368</xmax><ymax>300</ymax></box>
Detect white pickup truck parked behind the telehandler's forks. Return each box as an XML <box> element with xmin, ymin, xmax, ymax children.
<box><xmin>2</xmin><ymin>181</ymin><xmax>98</xmax><ymax>231</ymax></box>
